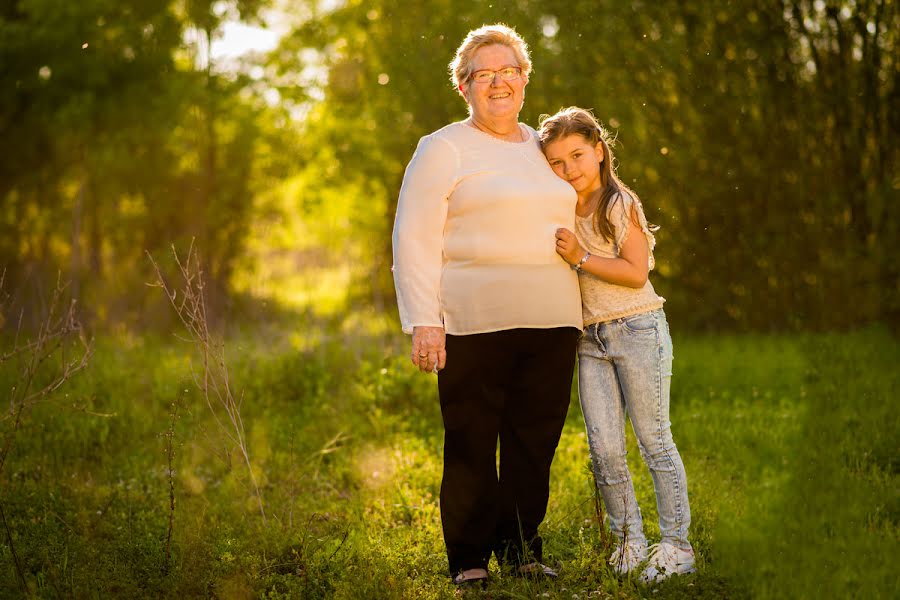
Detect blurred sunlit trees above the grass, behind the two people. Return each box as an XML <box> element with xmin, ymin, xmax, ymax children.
<box><xmin>0</xmin><ymin>0</ymin><xmax>900</xmax><ymax>331</ymax></box>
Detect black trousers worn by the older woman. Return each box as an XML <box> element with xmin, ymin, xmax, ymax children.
<box><xmin>438</xmin><ymin>327</ymin><xmax>579</xmax><ymax>573</ymax></box>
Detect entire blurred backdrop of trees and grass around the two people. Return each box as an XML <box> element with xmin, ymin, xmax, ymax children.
<box><xmin>0</xmin><ymin>0</ymin><xmax>900</xmax><ymax>600</ymax></box>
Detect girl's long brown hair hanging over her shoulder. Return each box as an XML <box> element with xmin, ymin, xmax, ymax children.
<box><xmin>538</xmin><ymin>106</ymin><xmax>658</xmax><ymax>242</ymax></box>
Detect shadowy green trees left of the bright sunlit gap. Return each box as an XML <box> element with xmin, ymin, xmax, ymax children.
<box><xmin>0</xmin><ymin>0</ymin><xmax>284</xmax><ymax>324</ymax></box>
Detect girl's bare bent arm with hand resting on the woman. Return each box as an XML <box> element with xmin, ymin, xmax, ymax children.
<box><xmin>556</xmin><ymin>207</ymin><xmax>650</xmax><ymax>288</ymax></box>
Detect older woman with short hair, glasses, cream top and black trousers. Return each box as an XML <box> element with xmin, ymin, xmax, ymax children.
<box><xmin>393</xmin><ymin>25</ymin><xmax>582</xmax><ymax>584</ymax></box>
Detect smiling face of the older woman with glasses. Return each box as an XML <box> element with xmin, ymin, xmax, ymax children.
<box><xmin>462</xmin><ymin>44</ymin><xmax>528</xmax><ymax>121</ymax></box>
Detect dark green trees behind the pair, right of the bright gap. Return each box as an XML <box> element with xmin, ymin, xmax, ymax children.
<box><xmin>279</xmin><ymin>0</ymin><xmax>900</xmax><ymax>330</ymax></box>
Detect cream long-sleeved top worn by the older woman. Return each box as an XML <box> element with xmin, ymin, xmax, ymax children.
<box><xmin>393</xmin><ymin>123</ymin><xmax>582</xmax><ymax>335</ymax></box>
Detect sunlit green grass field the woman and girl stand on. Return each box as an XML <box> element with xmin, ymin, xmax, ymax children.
<box><xmin>0</xmin><ymin>324</ymin><xmax>900</xmax><ymax>599</ymax></box>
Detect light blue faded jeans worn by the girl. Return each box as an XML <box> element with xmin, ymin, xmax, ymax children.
<box><xmin>578</xmin><ymin>309</ymin><xmax>691</xmax><ymax>550</ymax></box>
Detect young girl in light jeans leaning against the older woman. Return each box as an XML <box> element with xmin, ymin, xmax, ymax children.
<box><xmin>539</xmin><ymin>108</ymin><xmax>694</xmax><ymax>582</ymax></box>
